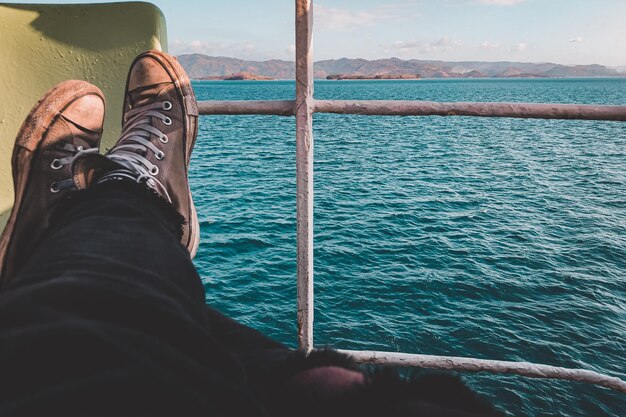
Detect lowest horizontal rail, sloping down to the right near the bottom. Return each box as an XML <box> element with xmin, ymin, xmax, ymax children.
<box><xmin>339</xmin><ymin>350</ymin><xmax>626</xmax><ymax>393</ymax></box>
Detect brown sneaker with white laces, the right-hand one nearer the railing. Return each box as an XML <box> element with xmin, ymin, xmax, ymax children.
<box><xmin>98</xmin><ymin>50</ymin><xmax>200</xmax><ymax>258</ymax></box>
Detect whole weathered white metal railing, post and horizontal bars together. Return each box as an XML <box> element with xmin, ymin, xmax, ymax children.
<box><xmin>198</xmin><ymin>0</ymin><xmax>626</xmax><ymax>393</ymax></box>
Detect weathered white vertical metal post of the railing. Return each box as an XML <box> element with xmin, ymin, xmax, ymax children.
<box><xmin>295</xmin><ymin>0</ymin><xmax>313</xmax><ymax>352</ymax></box>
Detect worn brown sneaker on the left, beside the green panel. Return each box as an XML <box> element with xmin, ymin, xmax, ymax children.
<box><xmin>0</xmin><ymin>80</ymin><xmax>104</xmax><ymax>287</ymax></box>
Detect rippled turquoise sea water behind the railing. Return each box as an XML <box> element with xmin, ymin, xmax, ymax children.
<box><xmin>190</xmin><ymin>79</ymin><xmax>626</xmax><ymax>417</ymax></box>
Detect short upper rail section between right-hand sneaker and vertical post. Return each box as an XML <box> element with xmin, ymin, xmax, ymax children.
<box><xmin>198</xmin><ymin>100</ymin><xmax>296</xmax><ymax>116</ymax></box>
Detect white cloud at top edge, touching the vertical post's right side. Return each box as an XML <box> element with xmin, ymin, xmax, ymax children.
<box><xmin>313</xmin><ymin>3</ymin><xmax>418</xmax><ymax>31</ymax></box>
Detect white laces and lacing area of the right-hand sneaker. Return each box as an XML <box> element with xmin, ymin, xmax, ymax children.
<box><xmin>106</xmin><ymin>101</ymin><xmax>172</xmax><ymax>203</ymax></box>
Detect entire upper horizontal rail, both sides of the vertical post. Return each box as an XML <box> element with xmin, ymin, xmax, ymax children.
<box><xmin>198</xmin><ymin>100</ymin><xmax>626</xmax><ymax>121</ymax></box>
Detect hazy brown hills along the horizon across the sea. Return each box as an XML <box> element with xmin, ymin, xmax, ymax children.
<box><xmin>178</xmin><ymin>54</ymin><xmax>626</xmax><ymax>80</ymax></box>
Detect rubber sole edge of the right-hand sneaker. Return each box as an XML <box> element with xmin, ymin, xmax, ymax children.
<box><xmin>129</xmin><ymin>50</ymin><xmax>200</xmax><ymax>259</ymax></box>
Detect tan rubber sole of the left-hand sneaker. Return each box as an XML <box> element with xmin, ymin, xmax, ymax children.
<box><xmin>0</xmin><ymin>80</ymin><xmax>104</xmax><ymax>288</ymax></box>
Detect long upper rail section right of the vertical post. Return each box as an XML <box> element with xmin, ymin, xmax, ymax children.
<box><xmin>315</xmin><ymin>100</ymin><xmax>626</xmax><ymax>121</ymax></box>
